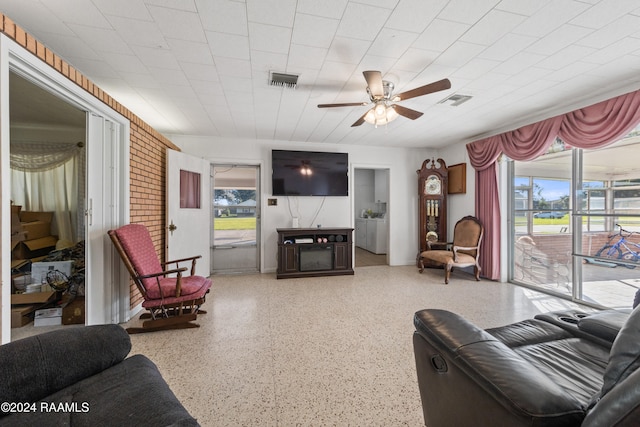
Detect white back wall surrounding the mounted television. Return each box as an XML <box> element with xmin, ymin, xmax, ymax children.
<box><xmin>168</xmin><ymin>135</ymin><xmax>436</xmax><ymax>272</ymax></box>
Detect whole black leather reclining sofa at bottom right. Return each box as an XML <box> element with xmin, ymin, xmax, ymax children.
<box><xmin>413</xmin><ymin>307</ymin><xmax>640</xmax><ymax>427</ymax></box>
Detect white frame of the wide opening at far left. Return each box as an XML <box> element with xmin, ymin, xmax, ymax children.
<box><xmin>0</xmin><ymin>34</ymin><xmax>131</xmax><ymax>343</ymax></box>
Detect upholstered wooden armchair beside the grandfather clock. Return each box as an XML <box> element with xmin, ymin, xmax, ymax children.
<box><xmin>418</xmin><ymin>216</ymin><xmax>484</xmax><ymax>283</ymax></box>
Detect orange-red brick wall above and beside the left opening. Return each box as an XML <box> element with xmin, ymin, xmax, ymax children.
<box><xmin>0</xmin><ymin>13</ymin><xmax>179</xmax><ymax>307</ymax></box>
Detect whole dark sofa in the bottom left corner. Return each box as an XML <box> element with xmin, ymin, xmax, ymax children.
<box><xmin>0</xmin><ymin>325</ymin><xmax>199</xmax><ymax>427</ymax></box>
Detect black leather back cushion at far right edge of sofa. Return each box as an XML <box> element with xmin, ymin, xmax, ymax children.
<box><xmin>600</xmin><ymin>307</ymin><xmax>640</xmax><ymax>398</ymax></box>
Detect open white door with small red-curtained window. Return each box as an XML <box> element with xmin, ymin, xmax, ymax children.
<box><xmin>166</xmin><ymin>149</ymin><xmax>211</xmax><ymax>277</ymax></box>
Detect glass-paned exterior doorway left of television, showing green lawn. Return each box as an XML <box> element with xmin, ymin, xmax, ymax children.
<box><xmin>211</xmin><ymin>164</ymin><xmax>261</xmax><ymax>274</ymax></box>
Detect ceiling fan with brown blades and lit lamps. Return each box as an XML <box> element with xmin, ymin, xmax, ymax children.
<box><xmin>318</xmin><ymin>71</ymin><xmax>451</xmax><ymax>127</ymax></box>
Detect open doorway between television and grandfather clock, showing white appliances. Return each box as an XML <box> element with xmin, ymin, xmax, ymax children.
<box><xmin>354</xmin><ymin>169</ymin><xmax>389</xmax><ymax>254</ymax></box>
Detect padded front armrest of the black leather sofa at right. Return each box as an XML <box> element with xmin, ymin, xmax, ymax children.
<box><xmin>414</xmin><ymin>309</ymin><xmax>586</xmax><ymax>424</ymax></box>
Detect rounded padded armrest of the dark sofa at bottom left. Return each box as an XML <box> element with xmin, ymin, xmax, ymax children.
<box><xmin>0</xmin><ymin>325</ymin><xmax>131</xmax><ymax>410</ymax></box>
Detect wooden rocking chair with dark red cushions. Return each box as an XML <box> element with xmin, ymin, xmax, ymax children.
<box><xmin>108</xmin><ymin>224</ymin><xmax>211</xmax><ymax>334</ymax></box>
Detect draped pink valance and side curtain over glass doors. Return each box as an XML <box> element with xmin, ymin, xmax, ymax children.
<box><xmin>467</xmin><ymin>91</ymin><xmax>640</xmax><ymax>280</ymax></box>
